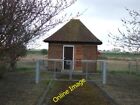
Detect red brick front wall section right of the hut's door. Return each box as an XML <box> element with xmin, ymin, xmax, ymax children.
<box><xmin>75</xmin><ymin>45</ymin><xmax>97</xmax><ymax>72</ymax></box>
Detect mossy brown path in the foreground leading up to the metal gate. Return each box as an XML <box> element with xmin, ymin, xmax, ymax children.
<box><xmin>43</xmin><ymin>81</ymin><xmax>116</xmax><ymax>105</ymax></box>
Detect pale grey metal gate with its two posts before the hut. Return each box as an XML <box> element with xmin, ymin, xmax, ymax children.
<box><xmin>35</xmin><ymin>59</ymin><xmax>107</xmax><ymax>84</ymax></box>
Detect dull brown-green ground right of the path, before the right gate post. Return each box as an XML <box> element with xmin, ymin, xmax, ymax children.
<box><xmin>98</xmin><ymin>74</ymin><xmax>140</xmax><ymax>105</ymax></box>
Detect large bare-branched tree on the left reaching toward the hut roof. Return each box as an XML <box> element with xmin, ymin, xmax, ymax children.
<box><xmin>0</xmin><ymin>0</ymin><xmax>76</xmax><ymax>70</ymax></box>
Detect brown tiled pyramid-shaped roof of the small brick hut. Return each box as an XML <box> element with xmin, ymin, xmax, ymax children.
<box><xmin>44</xmin><ymin>19</ymin><xmax>102</xmax><ymax>45</ymax></box>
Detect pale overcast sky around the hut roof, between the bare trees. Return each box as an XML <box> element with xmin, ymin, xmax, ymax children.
<box><xmin>30</xmin><ymin>0</ymin><xmax>140</xmax><ymax>50</ymax></box>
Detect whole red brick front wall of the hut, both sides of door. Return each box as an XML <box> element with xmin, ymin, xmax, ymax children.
<box><xmin>48</xmin><ymin>43</ymin><xmax>97</xmax><ymax>72</ymax></box>
